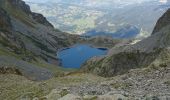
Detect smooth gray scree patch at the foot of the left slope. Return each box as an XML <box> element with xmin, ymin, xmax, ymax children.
<box><xmin>0</xmin><ymin>56</ymin><xmax>53</xmax><ymax>81</ymax></box>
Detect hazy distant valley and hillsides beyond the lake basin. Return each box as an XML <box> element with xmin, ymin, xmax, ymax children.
<box><xmin>26</xmin><ymin>0</ymin><xmax>170</xmax><ymax>38</ymax></box>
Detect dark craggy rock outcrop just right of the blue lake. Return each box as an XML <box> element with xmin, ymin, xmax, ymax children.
<box><xmin>84</xmin><ymin>51</ymin><xmax>158</xmax><ymax>77</ymax></box>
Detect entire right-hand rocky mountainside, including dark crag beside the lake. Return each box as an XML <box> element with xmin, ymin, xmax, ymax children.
<box><xmin>83</xmin><ymin>10</ymin><xmax>170</xmax><ymax>77</ymax></box>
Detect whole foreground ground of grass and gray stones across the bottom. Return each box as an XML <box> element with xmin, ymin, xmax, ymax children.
<box><xmin>0</xmin><ymin>63</ymin><xmax>170</xmax><ymax>100</ymax></box>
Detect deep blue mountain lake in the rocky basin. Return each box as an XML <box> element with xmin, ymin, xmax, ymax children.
<box><xmin>57</xmin><ymin>45</ymin><xmax>108</xmax><ymax>68</ymax></box>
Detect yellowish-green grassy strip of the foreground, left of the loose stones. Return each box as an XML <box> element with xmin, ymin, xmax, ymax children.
<box><xmin>0</xmin><ymin>74</ymin><xmax>103</xmax><ymax>100</ymax></box>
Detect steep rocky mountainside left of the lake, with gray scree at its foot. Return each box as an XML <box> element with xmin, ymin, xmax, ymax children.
<box><xmin>0</xmin><ymin>0</ymin><xmax>79</xmax><ymax>80</ymax></box>
